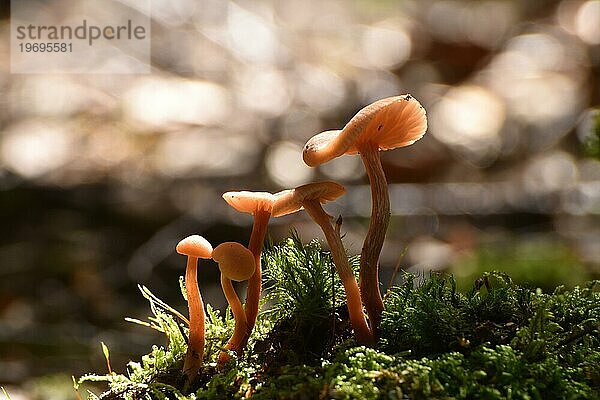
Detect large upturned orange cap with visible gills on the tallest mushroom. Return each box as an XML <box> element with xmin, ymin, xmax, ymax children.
<box><xmin>302</xmin><ymin>94</ymin><xmax>427</xmax><ymax>167</ymax></box>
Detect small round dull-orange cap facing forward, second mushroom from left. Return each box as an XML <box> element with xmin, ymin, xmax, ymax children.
<box><xmin>212</xmin><ymin>242</ymin><xmax>256</xmax><ymax>282</ymax></box>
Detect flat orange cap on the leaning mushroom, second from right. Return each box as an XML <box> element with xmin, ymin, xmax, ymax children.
<box><xmin>272</xmin><ymin>181</ymin><xmax>346</xmax><ymax>217</ymax></box>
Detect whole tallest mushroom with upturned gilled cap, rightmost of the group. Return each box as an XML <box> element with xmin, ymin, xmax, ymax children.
<box><xmin>303</xmin><ymin>94</ymin><xmax>427</xmax><ymax>337</ymax></box>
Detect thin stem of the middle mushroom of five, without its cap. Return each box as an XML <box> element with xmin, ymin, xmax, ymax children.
<box><xmin>244</xmin><ymin>210</ymin><xmax>271</xmax><ymax>336</ymax></box>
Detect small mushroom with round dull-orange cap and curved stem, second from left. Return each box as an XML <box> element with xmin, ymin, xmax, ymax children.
<box><xmin>212</xmin><ymin>242</ymin><xmax>256</xmax><ymax>365</ymax></box>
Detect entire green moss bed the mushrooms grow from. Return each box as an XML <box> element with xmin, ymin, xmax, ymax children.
<box><xmin>80</xmin><ymin>236</ymin><xmax>600</xmax><ymax>400</ymax></box>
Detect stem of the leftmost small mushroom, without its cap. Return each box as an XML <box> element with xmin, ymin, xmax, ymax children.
<box><xmin>183</xmin><ymin>256</ymin><xmax>205</xmax><ymax>382</ymax></box>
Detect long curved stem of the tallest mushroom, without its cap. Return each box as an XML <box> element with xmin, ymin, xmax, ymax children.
<box><xmin>359</xmin><ymin>146</ymin><xmax>390</xmax><ymax>338</ymax></box>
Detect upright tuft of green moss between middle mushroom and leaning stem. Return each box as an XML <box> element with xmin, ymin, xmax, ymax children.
<box><xmin>257</xmin><ymin>234</ymin><xmax>358</xmax><ymax>369</ymax></box>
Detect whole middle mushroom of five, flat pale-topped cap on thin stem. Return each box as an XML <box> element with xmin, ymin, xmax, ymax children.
<box><xmin>223</xmin><ymin>191</ymin><xmax>275</xmax><ymax>342</ymax></box>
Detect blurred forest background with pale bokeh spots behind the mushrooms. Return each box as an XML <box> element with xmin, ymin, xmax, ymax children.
<box><xmin>0</xmin><ymin>0</ymin><xmax>600</xmax><ymax>399</ymax></box>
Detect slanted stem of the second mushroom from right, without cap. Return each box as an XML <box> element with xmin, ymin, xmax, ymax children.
<box><xmin>302</xmin><ymin>200</ymin><xmax>374</xmax><ymax>345</ymax></box>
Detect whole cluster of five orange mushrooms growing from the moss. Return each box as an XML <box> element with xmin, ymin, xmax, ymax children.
<box><xmin>176</xmin><ymin>95</ymin><xmax>427</xmax><ymax>381</ymax></box>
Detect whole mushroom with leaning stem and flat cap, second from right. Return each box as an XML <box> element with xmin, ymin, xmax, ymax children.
<box><xmin>273</xmin><ymin>182</ymin><xmax>373</xmax><ymax>344</ymax></box>
